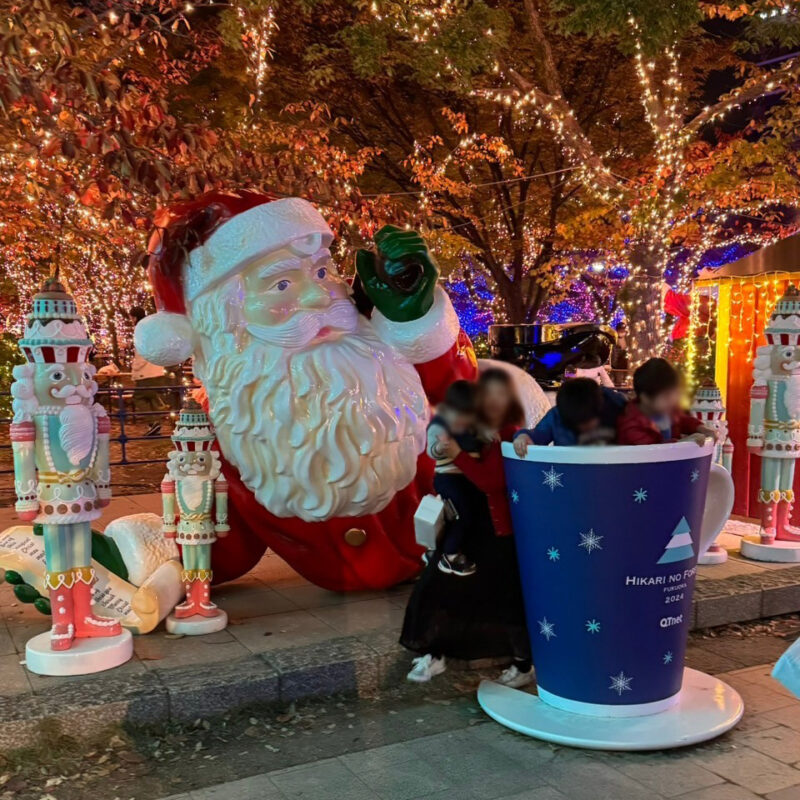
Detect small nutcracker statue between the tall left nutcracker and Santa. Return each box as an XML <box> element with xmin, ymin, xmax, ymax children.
<box><xmin>161</xmin><ymin>401</ymin><xmax>229</xmax><ymax>635</ymax></box>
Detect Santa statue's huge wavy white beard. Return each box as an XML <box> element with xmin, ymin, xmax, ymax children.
<box><xmin>190</xmin><ymin>280</ymin><xmax>428</xmax><ymax>522</ymax></box>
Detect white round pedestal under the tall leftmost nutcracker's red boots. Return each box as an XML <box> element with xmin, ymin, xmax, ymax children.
<box><xmin>25</xmin><ymin>628</ymin><xmax>133</xmax><ymax>675</ymax></box>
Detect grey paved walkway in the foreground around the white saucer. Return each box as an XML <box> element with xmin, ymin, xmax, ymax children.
<box><xmin>142</xmin><ymin>667</ymin><xmax>800</xmax><ymax>800</ymax></box>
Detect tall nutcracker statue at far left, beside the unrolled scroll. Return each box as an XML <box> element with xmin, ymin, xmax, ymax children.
<box><xmin>11</xmin><ymin>275</ymin><xmax>133</xmax><ymax>675</ymax></box>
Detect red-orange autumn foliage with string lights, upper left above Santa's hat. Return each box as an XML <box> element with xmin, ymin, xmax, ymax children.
<box><xmin>0</xmin><ymin>0</ymin><xmax>382</xmax><ymax>355</ymax></box>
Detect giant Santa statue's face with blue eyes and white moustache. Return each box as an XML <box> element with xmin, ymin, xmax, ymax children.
<box><xmin>242</xmin><ymin>237</ymin><xmax>357</xmax><ymax>349</ymax></box>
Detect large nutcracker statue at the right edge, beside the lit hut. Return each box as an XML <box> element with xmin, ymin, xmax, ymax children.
<box><xmin>742</xmin><ymin>286</ymin><xmax>800</xmax><ymax>561</ymax></box>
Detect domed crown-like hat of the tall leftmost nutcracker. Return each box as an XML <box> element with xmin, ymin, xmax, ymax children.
<box><xmin>19</xmin><ymin>273</ymin><xmax>93</xmax><ymax>364</ymax></box>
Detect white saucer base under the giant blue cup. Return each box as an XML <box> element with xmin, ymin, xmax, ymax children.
<box><xmin>478</xmin><ymin>669</ymin><xmax>744</xmax><ymax>750</ymax></box>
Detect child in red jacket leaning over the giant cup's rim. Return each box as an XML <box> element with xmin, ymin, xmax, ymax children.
<box><xmin>617</xmin><ymin>358</ymin><xmax>716</xmax><ymax>445</ymax></box>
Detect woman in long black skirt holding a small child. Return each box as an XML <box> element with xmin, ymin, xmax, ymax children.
<box><xmin>400</xmin><ymin>369</ymin><xmax>532</xmax><ymax>688</ymax></box>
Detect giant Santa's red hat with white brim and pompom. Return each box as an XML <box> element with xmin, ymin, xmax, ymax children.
<box><xmin>134</xmin><ymin>192</ymin><xmax>333</xmax><ymax>367</ymax></box>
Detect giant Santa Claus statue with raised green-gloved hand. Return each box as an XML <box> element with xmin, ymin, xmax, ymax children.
<box><xmin>135</xmin><ymin>192</ymin><xmax>540</xmax><ymax>591</ymax></box>
